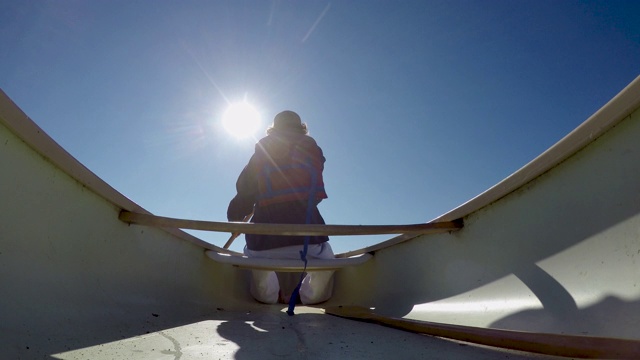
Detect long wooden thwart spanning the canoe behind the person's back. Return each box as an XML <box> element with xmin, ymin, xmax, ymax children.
<box><xmin>119</xmin><ymin>210</ymin><xmax>463</xmax><ymax>236</ymax></box>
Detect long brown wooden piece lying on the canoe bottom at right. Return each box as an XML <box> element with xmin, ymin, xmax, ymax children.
<box><xmin>325</xmin><ymin>306</ymin><xmax>640</xmax><ymax>359</ymax></box>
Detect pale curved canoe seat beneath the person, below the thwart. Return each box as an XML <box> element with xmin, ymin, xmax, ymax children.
<box><xmin>205</xmin><ymin>250</ymin><xmax>373</xmax><ymax>272</ymax></box>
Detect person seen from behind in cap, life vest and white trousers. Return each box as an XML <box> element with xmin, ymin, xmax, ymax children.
<box><xmin>227</xmin><ymin>111</ymin><xmax>334</xmax><ymax>304</ymax></box>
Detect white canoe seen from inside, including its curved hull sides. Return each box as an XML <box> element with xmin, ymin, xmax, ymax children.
<box><xmin>0</xmin><ymin>78</ymin><xmax>640</xmax><ymax>360</ymax></box>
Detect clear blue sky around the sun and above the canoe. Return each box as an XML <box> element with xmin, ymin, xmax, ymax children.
<box><xmin>0</xmin><ymin>0</ymin><xmax>640</xmax><ymax>252</ymax></box>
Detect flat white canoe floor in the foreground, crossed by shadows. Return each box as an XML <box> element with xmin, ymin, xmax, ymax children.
<box><xmin>47</xmin><ymin>307</ymin><xmax>566</xmax><ymax>360</ymax></box>
